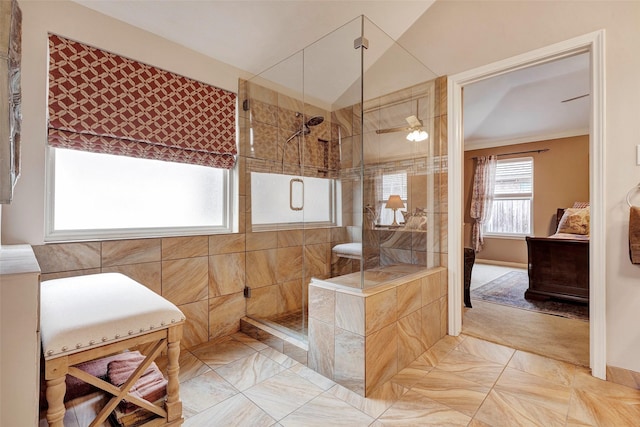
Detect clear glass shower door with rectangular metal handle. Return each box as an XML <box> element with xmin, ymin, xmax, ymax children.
<box><xmin>240</xmin><ymin>47</ymin><xmax>306</xmax><ymax>339</ymax></box>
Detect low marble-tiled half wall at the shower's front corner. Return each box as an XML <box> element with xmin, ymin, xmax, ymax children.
<box><xmin>308</xmin><ymin>267</ymin><xmax>447</xmax><ymax>396</ymax></box>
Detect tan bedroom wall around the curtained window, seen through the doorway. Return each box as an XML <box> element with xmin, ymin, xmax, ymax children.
<box><xmin>463</xmin><ymin>135</ymin><xmax>589</xmax><ymax>264</ymax></box>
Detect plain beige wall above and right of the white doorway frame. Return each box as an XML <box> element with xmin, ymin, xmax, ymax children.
<box><xmin>399</xmin><ymin>0</ymin><xmax>640</xmax><ymax>372</ymax></box>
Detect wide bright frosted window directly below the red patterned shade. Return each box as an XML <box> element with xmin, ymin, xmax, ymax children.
<box><xmin>47</xmin><ymin>148</ymin><xmax>232</xmax><ymax>241</ymax></box>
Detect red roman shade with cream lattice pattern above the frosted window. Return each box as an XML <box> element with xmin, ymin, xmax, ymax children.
<box><xmin>49</xmin><ymin>35</ymin><xmax>237</xmax><ymax>169</ymax></box>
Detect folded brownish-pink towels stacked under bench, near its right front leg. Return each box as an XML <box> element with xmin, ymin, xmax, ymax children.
<box><xmin>107</xmin><ymin>352</ymin><xmax>167</xmax><ymax>413</ymax></box>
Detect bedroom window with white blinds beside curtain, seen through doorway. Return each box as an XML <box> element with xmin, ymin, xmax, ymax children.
<box><xmin>484</xmin><ymin>158</ymin><xmax>533</xmax><ymax>236</ymax></box>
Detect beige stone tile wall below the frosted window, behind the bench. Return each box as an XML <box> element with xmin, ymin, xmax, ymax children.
<box><xmin>33</xmin><ymin>234</ymin><xmax>246</xmax><ymax>347</ymax></box>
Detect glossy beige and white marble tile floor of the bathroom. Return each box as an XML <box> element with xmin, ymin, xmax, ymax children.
<box><xmin>45</xmin><ymin>333</ymin><xmax>640</xmax><ymax>427</ymax></box>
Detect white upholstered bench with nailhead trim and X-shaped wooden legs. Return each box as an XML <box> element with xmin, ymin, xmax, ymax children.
<box><xmin>40</xmin><ymin>273</ymin><xmax>185</xmax><ymax>427</ymax></box>
